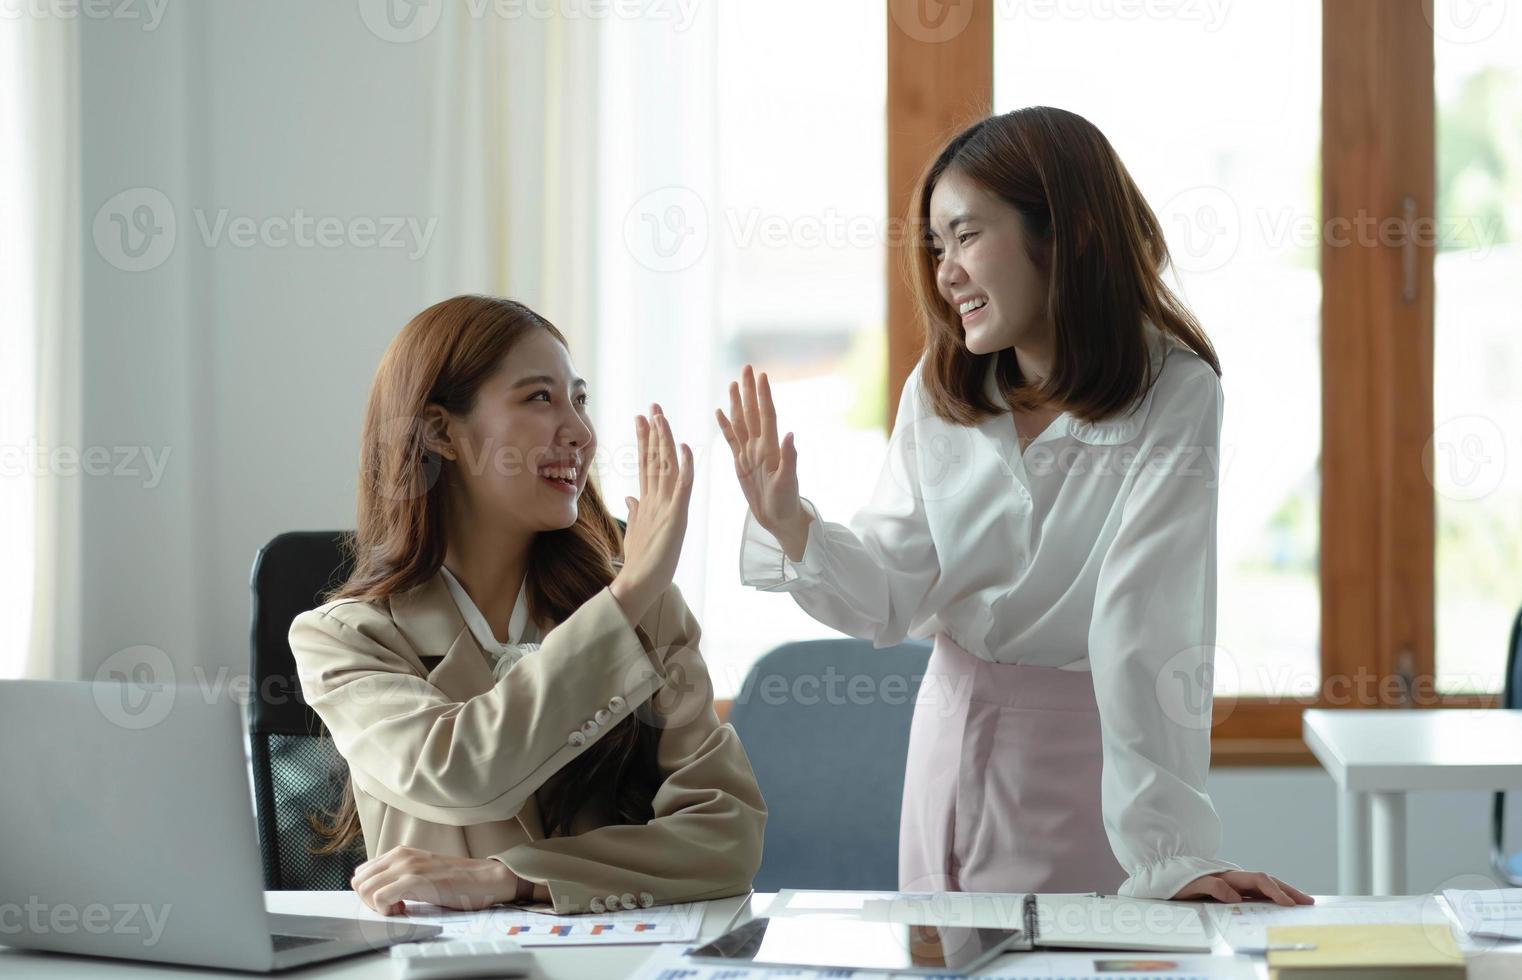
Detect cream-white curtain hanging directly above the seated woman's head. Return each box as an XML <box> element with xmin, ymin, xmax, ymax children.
<box><xmin>428</xmin><ymin>5</ymin><xmax>603</xmax><ymax>362</ymax></box>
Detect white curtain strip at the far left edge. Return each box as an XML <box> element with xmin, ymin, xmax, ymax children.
<box><xmin>0</xmin><ymin>17</ymin><xmax>85</xmax><ymax>679</ymax></box>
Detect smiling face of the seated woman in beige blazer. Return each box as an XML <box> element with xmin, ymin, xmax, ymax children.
<box><xmin>431</xmin><ymin>329</ymin><xmax>597</xmax><ymax>534</ymax></box>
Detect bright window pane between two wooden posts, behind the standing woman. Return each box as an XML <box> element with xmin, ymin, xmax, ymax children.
<box><xmin>994</xmin><ymin>3</ymin><xmax>1321</xmax><ymax>697</ymax></box>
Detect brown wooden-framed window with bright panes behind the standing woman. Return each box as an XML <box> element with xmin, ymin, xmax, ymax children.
<box><xmin>889</xmin><ymin>0</ymin><xmax>1522</xmax><ymax>764</ymax></box>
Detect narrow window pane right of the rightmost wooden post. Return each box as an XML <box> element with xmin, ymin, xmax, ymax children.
<box><xmin>1426</xmin><ymin>9</ymin><xmax>1522</xmax><ymax>694</ymax></box>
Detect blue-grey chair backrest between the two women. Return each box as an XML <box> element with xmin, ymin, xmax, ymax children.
<box><xmin>729</xmin><ymin>639</ymin><xmax>930</xmax><ymax>892</ymax></box>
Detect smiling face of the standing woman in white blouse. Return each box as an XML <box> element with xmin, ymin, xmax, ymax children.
<box><xmin>930</xmin><ymin>170</ymin><xmax>1052</xmax><ymax>355</ymax></box>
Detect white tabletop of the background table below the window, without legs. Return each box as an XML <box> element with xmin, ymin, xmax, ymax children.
<box><xmin>1303</xmin><ymin>708</ymin><xmax>1522</xmax><ymax>791</ymax></box>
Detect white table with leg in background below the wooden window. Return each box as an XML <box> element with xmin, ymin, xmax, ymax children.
<box><xmin>1303</xmin><ymin>709</ymin><xmax>1522</xmax><ymax>895</ymax></box>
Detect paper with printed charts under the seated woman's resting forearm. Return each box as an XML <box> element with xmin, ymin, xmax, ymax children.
<box><xmin>392</xmin><ymin>902</ymin><xmax>705</xmax><ymax>947</ymax></box>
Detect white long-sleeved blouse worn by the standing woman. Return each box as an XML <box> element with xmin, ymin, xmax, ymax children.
<box><xmin>740</xmin><ymin>324</ymin><xmax>1237</xmax><ymax>898</ymax></box>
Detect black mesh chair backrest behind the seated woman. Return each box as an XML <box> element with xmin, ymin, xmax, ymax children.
<box><xmin>248</xmin><ymin>531</ymin><xmax>365</xmax><ymax>890</ymax></box>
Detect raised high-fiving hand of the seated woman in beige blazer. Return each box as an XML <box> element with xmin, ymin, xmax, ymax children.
<box><xmin>610</xmin><ymin>405</ymin><xmax>693</xmax><ymax>624</ymax></box>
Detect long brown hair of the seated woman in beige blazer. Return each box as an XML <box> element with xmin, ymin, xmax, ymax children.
<box><xmin>309</xmin><ymin>295</ymin><xmax>661</xmax><ymax>854</ymax></box>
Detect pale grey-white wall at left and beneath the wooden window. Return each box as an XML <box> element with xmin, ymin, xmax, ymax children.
<box><xmin>82</xmin><ymin>0</ymin><xmax>1522</xmax><ymax>893</ymax></box>
